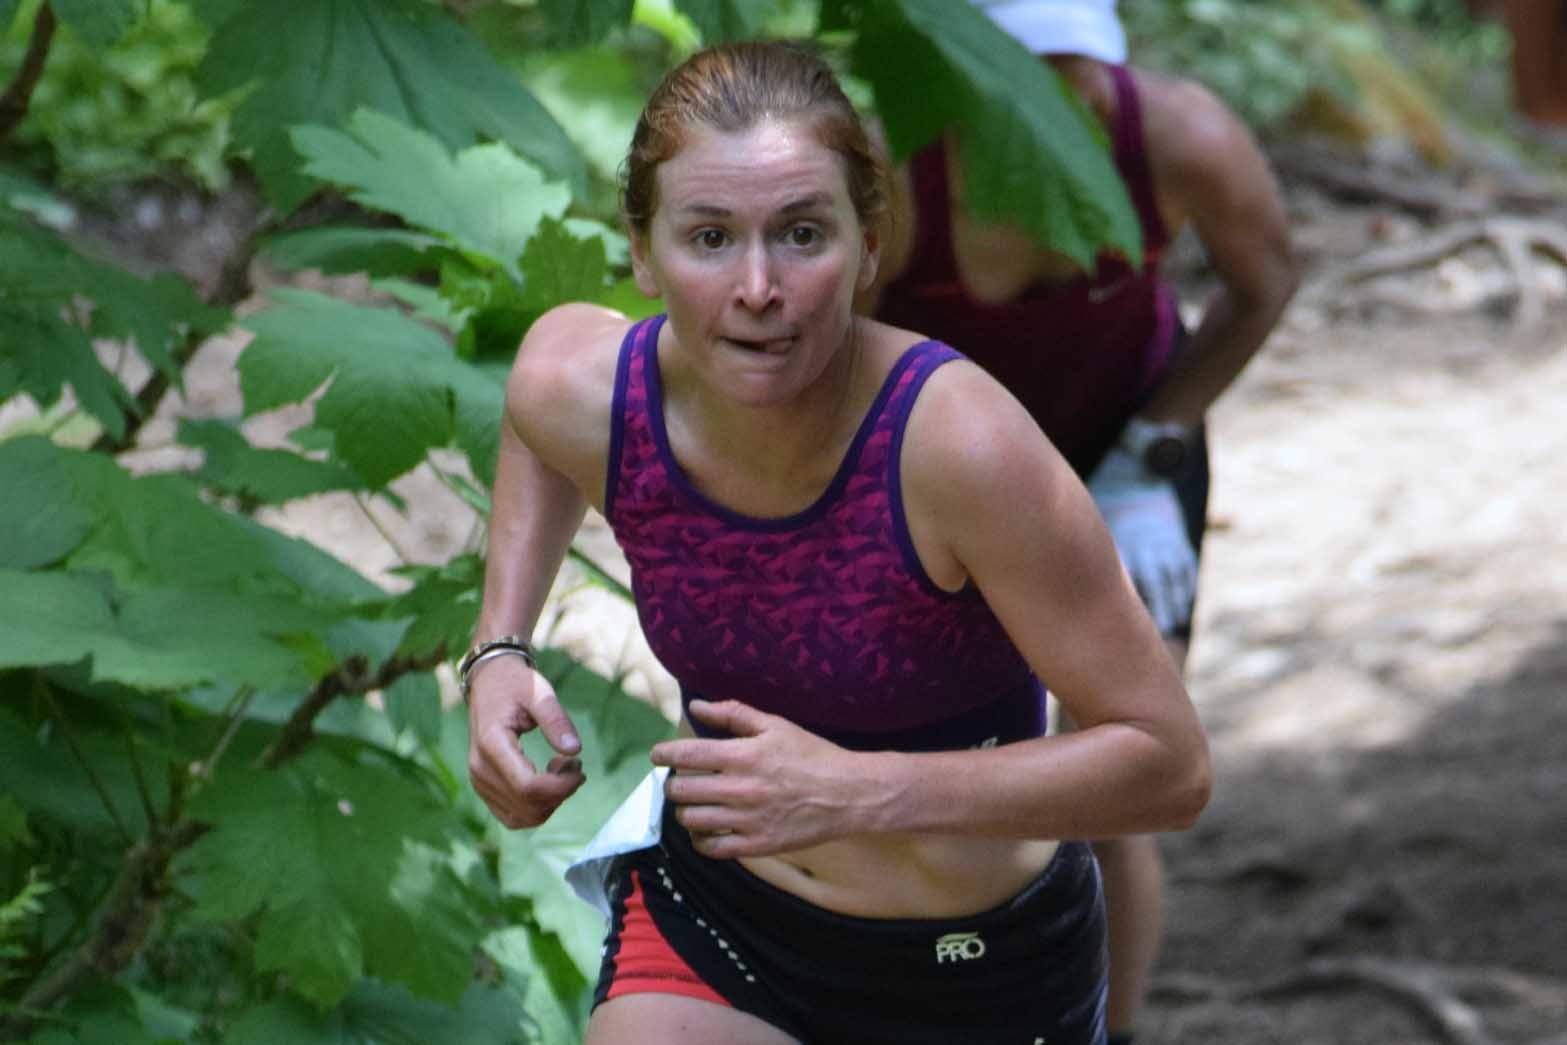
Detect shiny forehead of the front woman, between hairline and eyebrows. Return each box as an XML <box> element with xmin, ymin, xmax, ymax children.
<box><xmin>658</xmin><ymin>119</ymin><xmax>849</xmax><ymax>210</ymax></box>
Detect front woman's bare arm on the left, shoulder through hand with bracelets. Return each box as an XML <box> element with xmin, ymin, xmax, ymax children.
<box><xmin>469</xmin><ymin>306</ymin><xmax>625</xmax><ymax>827</ymax></box>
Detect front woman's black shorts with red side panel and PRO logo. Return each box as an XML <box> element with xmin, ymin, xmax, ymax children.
<box><xmin>594</xmin><ymin>810</ymin><xmax>1108</xmax><ymax>1045</ymax></box>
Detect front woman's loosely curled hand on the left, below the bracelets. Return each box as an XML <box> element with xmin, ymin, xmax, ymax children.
<box><xmin>469</xmin><ymin>656</ymin><xmax>586</xmax><ymax>830</ymax></box>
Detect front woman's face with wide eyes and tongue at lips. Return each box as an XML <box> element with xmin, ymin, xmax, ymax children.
<box><xmin>632</xmin><ymin>119</ymin><xmax>878</xmax><ymax>406</ymax></box>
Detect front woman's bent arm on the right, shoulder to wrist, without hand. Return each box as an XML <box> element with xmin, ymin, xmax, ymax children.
<box><xmin>870</xmin><ymin>363</ymin><xmax>1211</xmax><ymax>838</ymax></box>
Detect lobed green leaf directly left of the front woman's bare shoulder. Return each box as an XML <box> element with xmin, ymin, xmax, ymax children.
<box><xmin>240</xmin><ymin>290</ymin><xmax>505</xmax><ymax>489</ymax></box>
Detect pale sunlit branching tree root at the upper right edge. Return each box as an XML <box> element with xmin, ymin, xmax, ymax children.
<box><xmin>1302</xmin><ymin>218</ymin><xmax>1567</xmax><ymax>329</ymax></box>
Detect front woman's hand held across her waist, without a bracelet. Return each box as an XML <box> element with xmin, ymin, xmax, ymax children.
<box><xmin>652</xmin><ymin>700</ymin><xmax>867</xmax><ymax>859</ymax></box>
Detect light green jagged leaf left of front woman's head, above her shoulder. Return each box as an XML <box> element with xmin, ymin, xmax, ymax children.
<box><xmin>293</xmin><ymin>110</ymin><xmax>570</xmax><ymax>277</ymax></box>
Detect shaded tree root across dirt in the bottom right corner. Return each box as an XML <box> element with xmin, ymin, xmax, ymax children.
<box><xmin>1149</xmin><ymin>957</ymin><xmax>1567</xmax><ymax>1045</ymax></box>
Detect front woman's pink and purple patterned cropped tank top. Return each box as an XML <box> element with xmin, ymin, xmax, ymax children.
<box><xmin>605</xmin><ymin>316</ymin><xmax>1045</xmax><ymax>750</ymax></box>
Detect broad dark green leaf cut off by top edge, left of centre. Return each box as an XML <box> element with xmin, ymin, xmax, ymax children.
<box><xmin>199</xmin><ymin>0</ymin><xmax>586</xmax><ymax>210</ymax></box>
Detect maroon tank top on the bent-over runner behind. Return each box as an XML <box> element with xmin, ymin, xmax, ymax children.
<box><xmin>876</xmin><ymin>66</ymin><xmax>1178</xmax><ymax>475</ymax></box>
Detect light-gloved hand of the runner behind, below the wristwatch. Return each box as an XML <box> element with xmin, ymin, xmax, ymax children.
<box><xmin>1087</xmin><ymin>447</ymin><xmax>1197</xmax><ymax>638</ymax></box>
